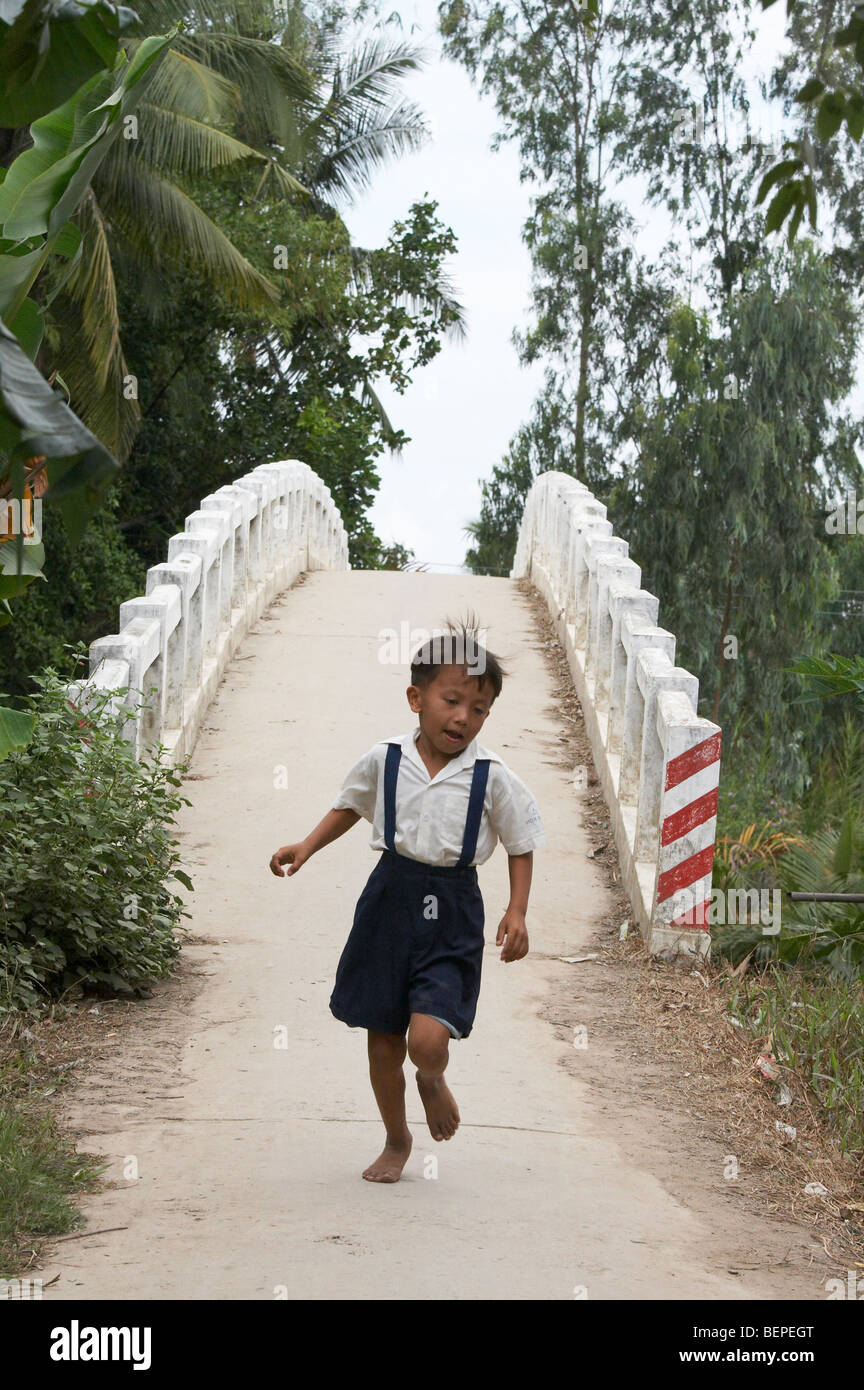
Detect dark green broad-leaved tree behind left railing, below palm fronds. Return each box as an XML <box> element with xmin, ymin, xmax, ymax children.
<box><xmin>109</xmin><ymin>186</ymin><xmax>461</xmax><ymax>569</ymax></box>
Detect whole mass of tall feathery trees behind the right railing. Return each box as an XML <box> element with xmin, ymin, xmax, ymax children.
<box><xmin>450</xmin><ymin>0</ymin><xmax>864</xmax><ymax>876</ymax></box>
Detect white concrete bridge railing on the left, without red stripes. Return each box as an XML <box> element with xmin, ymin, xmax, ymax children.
<box><xmin>68</xmin><ymin>459</ymin><xmax>350</xmax><ymax>763</ymax></box>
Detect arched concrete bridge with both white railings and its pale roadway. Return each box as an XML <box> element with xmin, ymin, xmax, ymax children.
<box><xmin>37</xmin><ymin>461</ymin><xmax>825</xmax><ymax>1301</ymax></box>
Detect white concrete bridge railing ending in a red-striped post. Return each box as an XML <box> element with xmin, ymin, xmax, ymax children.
<box><xmin>510</xmin><ymin>471</ymin><xmax>721</xmax><ymax>956</ymax></box>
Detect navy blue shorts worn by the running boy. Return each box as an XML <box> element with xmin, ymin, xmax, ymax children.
<box><xmin>331</xmin><ymin>849</ymin><xmax>485</xmax><ymax>1037</ymax></box>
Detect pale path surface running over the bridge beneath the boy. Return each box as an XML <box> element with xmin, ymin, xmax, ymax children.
<box><xmin>43</xmin><ymin>573</ymin><xmax>828</xmax><ymax>1300</ymax></box>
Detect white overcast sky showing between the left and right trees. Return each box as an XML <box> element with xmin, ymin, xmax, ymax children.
<box><xmin>343</xmin><ymin>0</ymin><xmax>786</xmax><ymax>573</ymax></box>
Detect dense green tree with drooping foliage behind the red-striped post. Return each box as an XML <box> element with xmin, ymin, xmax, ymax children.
<box><xmin>608</xmin><ymin>246</ymin><xmax>860</xmax><ymax>778</ymax></box>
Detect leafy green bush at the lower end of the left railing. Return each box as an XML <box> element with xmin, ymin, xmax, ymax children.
<box><xmin>0</xmin><ymin>656</ymin><xmax>192</xmax><ymax>1012</ymax></box>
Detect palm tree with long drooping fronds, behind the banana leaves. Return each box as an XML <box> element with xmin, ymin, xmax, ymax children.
<box><xmin>44</xmin><ymin>0</ymin><xmax>464</xmax><ymax>457</ymax></box>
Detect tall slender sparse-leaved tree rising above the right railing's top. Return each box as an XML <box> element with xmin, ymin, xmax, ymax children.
<box><xmin>439</xmin><ymin>0</ymin><xmax>635</xmax><ymax>481</ymax></box>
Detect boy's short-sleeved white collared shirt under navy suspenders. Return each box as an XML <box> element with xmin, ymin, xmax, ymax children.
<box><xmin>333</xmin><ymin>724</ymin><xmax>546</xmax><ymax>866</ymax></box>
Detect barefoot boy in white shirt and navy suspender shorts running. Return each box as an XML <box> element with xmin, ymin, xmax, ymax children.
<box><xmin>269</xmin><ymin>624</ymin><xmax>546</xmax><ymax>1183</ymax></box>
